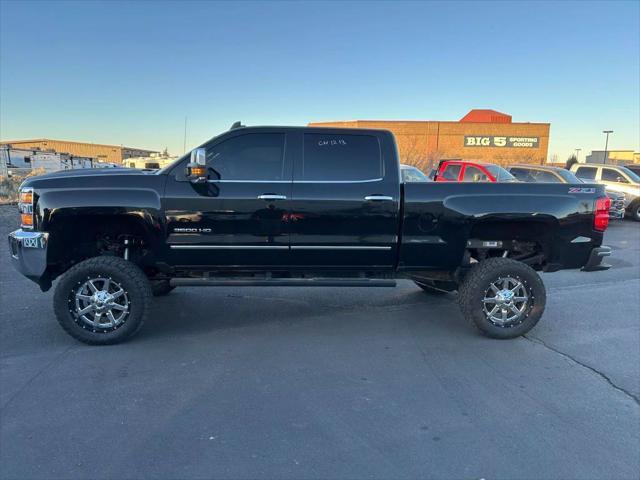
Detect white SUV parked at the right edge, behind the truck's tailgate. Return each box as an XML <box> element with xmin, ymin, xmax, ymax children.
<box><xmin>571</xmin><ymin>163</ymin><xmax>640</xmax><ymax>222</ymax></box>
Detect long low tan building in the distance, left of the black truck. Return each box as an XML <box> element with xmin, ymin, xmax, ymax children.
<box><xmin>0</xmin><ymin>138</ymin><xmax>159</xmax><ymax>163</ymax></box>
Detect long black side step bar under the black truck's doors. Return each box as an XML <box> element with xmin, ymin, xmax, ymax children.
<box><xmin>169</xmin><ymin>278</ymin><xmax>396</xmax><ymax>287</ymax></box>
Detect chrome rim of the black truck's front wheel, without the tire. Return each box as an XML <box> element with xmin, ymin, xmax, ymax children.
<box><xmin>69</xmin><ymin>277</ymin><xmax>129</xmax><ymax>332</ymax></box>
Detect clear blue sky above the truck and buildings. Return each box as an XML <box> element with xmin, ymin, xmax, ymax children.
<box><xmin>0</xmin><ymin>0</ymin><xmax>640</xmax><ymax>160</ymax></box>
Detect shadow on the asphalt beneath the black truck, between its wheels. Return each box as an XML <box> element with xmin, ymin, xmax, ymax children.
<box><xmin>141</xmin><ymin>286</ymin><xmax>474</xmax><ymax>342</ymax></box>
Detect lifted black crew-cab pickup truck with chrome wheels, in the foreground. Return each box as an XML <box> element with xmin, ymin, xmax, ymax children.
<box><xmin>9</xmin><ymin>126</ymin><xmax>610</xmax><ymax>344</ymax></box>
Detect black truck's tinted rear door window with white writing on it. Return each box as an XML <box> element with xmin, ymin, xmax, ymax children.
<box><xmin>295</xmin><ymin>133</ymin><xmax>384</xmax><ymax>182</ymax></box>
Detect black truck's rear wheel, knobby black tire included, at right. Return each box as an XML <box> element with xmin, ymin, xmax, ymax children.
<box><xmin>458</xmin><ymin>258</ymin><xmax>547</xmax><ymax>339</ymax></box>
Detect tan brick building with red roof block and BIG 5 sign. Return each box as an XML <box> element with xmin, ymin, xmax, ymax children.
<box><xmin>309</xmin><ymin>110</ymin><xmax>550</xmax><ymax>170</ymax></box>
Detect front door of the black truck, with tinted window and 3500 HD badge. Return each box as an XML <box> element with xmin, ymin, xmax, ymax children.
<box><xmin>163</xmin><ymin>129</ymin><xmax>292</xmax><ymax>268</ymax></box>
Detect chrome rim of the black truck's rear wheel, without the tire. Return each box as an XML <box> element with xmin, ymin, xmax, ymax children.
<box><xmin>482</xmin><ymin>277</ymin><xmax>533</xmax><ymax>327</ymax></box>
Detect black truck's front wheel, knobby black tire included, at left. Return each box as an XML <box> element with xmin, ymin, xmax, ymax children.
<box><xmin>53</xmin><ymin>256</ymin><xmax>151</xmax><ymax>345</ymax></box>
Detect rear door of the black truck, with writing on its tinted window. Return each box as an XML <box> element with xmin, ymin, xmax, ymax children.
<box><xmin>289</xmin><ymin>128</ymin><xmax>400</xmax><ymax>269</ymax></box>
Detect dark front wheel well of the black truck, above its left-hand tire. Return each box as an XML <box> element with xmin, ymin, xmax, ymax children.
<box><xmin>47</xmin><ymin>214</ymin><xmax>152</xmax><ymax>280</ymax></box>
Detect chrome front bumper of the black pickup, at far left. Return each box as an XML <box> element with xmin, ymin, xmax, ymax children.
<box><xmin>9</xmin><ymin>230</ymin><xmax>49</xmax><ymax>283</ymax></box>
